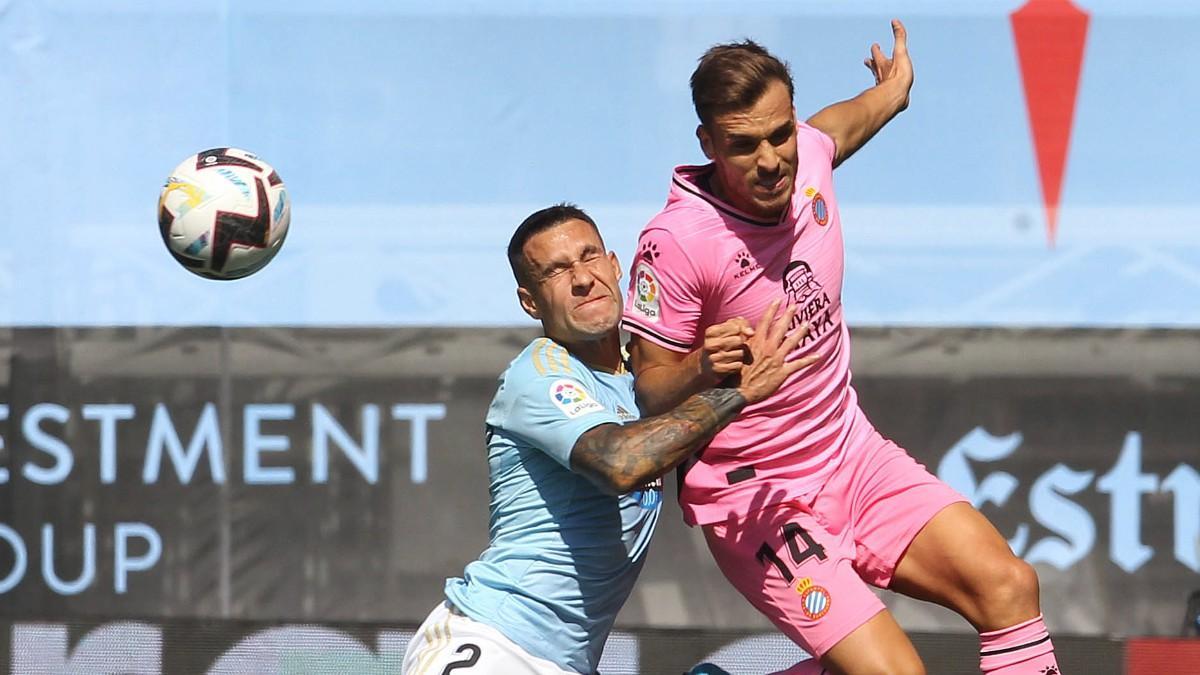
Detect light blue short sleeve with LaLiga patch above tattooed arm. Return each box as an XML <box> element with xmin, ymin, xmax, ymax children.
<box><xmin>503</xmin><ymin>374</ymin><xmax>620</xmax><ymax>468</ymax></box>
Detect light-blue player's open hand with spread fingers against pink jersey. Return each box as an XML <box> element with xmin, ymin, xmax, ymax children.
<box><xmin>738</xmin><ymin>300</ymin><xmax>820</xmax><ymax>404</ymax></box>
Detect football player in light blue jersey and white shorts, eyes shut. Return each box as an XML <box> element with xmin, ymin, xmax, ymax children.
<box><xmin>404</xmin><ymin>204</ymin><xmax>811</xmax><ymax>675</ymax></box>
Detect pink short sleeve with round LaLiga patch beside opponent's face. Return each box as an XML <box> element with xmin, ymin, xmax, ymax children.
<box><xmin>622</xmin><ymin>228</ymin><xmax>703</xmax><ymax>352</ymax></box>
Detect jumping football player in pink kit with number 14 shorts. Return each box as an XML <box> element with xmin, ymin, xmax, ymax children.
<box><xmin>624</xmin><ymin>22</ymin><xmax>1058</xmax><ymax>675</ymax></box>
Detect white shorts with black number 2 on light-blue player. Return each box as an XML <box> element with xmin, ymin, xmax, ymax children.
<box><xmin>403</xmin><ymin>602</ymin><xmax>578</xmax><ymax>675</ymax></box>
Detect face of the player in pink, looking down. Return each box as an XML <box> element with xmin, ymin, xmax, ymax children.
<box><xmin>696</xmin><ymin>79</ymin><xmax>797</xmax><ymax>219</ymax></box>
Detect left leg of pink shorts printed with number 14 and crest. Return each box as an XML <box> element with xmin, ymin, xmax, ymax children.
<box><xmin>704</xmin><ymin>502</ymin><xmax>883</xmax><ymax>656</ymax></box>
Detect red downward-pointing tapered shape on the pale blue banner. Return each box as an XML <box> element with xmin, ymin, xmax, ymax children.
<box><xmin>1009</xmin><ymin>0</ymin><xmax>1088</xmax><ymax>246</ymax></box>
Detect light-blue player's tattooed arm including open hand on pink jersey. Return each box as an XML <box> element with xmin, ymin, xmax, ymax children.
<box><xmin>571</xmin><ymin>301</ymin><xmax>816</xmax><ymax>495</ymax></box>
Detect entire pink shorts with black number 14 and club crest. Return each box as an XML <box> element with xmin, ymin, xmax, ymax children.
<box><xmin>704</xmin><ymin>430</ymin><xmax>967</xmax><ymax>657</ymax></box>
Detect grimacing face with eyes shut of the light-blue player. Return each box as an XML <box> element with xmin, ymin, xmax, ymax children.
<box><xmin>521</xmin><ymin>220</ymin><xmax>622</xmax><ymax>344</ymax></box>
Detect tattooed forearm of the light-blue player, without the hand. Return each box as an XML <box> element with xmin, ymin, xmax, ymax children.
<box><xmin>571</xmin><ymin>389</ymin><xmax>746</xmax><ymax>495</ymax></box>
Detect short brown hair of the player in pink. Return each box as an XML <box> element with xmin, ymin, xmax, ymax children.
<box><xmin>691</xmin><ymin>40</ymin><xmax>796</xmax><ymax>126</ymax></box>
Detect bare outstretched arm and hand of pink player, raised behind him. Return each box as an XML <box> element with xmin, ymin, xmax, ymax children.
<box><xmin>808</xmin><ymin>19</ymin><xmax>913</xmax><ymax>167</ymax></box>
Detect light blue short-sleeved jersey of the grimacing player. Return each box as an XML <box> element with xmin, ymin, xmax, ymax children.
<box><xmin>446</xmin><ymin>338</ymin><xmax>662</xmax><ymax>674</ymax></box>
